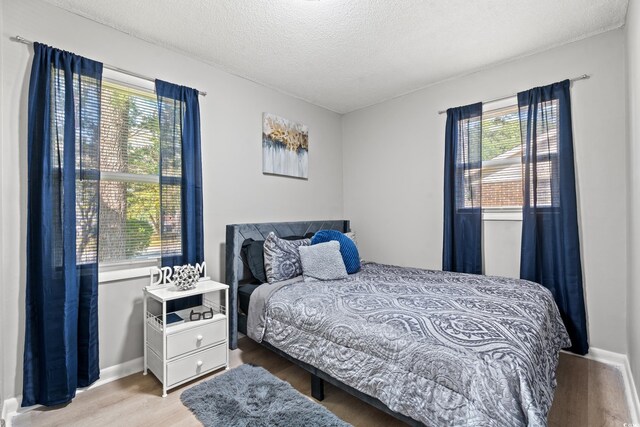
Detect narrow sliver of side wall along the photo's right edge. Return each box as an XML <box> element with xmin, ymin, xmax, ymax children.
<box><xmin>626</xmin><ymin>1</ymin><xmax>640</xmax><ymax>393</ymax></box>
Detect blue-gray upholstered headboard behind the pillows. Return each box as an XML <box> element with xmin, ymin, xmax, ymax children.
<box><xmin>225</xmin><ymin>219</ymin><xmax>351</xmax><ymax>349</ymax></box>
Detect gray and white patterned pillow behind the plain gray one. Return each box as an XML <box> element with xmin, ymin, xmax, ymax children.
<box><xmin>264</xmin><ymin>232</ymin><xmax>311</xmax><ymax>283</ymax></box>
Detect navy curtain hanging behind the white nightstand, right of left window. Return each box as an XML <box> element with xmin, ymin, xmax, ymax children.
<box><xmin>156</xmin><ymin>80</ymin><xmax>204</xmax><ymax>310</ymax></box>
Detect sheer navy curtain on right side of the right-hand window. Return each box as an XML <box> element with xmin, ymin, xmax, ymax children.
<box><xmin>518</xmin><ymin>80</ymin><xmax>589</xmax><ymax>354</ymax></box>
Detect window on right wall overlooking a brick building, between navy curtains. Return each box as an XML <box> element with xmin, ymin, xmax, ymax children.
<box><xmin>482</xmin><ymin>98</ymin><xmax>558</xmax><ymax>211</ymax></box>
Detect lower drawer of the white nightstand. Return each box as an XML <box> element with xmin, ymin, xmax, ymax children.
<box><xmin>167</xmin><ymin>343</ymin><xmax>227</xmax><ymax>387</ymax></box>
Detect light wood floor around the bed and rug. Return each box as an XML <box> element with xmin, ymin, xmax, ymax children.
<box><xmin>13</xmin><ymin>338</ymin><xmax>630</xmax><ymax>427</ymax></box>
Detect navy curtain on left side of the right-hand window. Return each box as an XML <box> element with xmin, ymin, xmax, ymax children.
<box><xmin>442</xmin><ymin>103</ymin><xmax>482</xmax><ymax>274</ymax></box>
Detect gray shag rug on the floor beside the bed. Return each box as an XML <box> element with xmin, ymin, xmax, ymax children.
<box><xmin>180</xmin><ymin>365</ymin><xmax>350</xmax><ymax>427</ymax></box>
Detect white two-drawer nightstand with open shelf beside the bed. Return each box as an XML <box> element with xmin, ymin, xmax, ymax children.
<box><xmin>143</xmin><ymin>280</ymin><xmax>229</xmax><ymax>397</ymax></box>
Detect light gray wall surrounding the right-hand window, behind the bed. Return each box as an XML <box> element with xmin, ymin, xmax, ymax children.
<box><xmin>342</xmin><ymin>30</ymin><xmax>627</xmax><ymax>353</ymax></box>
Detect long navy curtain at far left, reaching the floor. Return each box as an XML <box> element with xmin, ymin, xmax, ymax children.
<box><xmin>22</xmin><ymin>43</ymin><xmax>102</xmax><ymax>406</ymax></box>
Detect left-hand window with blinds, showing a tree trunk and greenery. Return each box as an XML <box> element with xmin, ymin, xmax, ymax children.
<box><xmin>99</xmin><ymin>79</ymin><xmax>181</xmax><ymax>263</ymax></box>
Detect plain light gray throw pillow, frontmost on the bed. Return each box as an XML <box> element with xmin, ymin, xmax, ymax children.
<box><xmin>298</xmin><ymin>240</ymin><xmax>349</xmax><ymax>282</ymax></box>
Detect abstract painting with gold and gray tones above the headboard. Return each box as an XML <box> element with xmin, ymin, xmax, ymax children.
<box><xmin>262</xmin><ymin>113</ymin><xmax>309</xmax><ymax>179</ymax></box>
